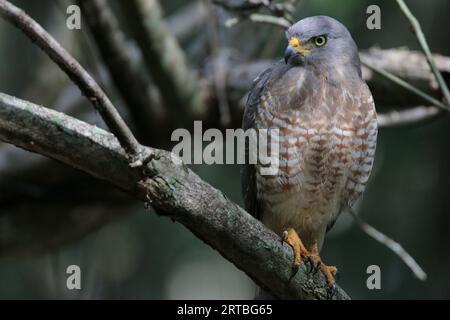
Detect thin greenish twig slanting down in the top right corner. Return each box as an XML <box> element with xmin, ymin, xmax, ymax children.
<box><xmin>397</xmin><ymin>0</ymin><xmax>450</xmax><ymax>109</ymax></box>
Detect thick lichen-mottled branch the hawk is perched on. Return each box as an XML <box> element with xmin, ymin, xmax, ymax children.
<box><xmin>0</xmin><ymin>94</ymin><xmax>348</xmax><ymax>299</ymax></box>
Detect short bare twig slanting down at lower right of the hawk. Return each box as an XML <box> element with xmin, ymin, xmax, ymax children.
<box><xmin>348</xmin><ymin>208</ymin><xmax>427</xmax><ymax>281</ymax></box>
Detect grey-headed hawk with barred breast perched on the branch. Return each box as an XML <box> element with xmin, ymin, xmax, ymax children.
<box><xmin>241</xmin><ymin>16</ymin><xmax>378</xmax><ymax>288</ymax></box>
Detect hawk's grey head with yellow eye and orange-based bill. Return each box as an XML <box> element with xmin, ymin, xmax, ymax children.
<box><xmin>284</xmin><ymin>16</ymin><xmax>360</xmax><ymax>70</ymax></box>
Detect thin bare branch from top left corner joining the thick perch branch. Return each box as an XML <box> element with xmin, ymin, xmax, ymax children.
<box><xmin>0</xmin><ymin>0</ymin><xmax>140</xmax><ymax>157</ymax></box>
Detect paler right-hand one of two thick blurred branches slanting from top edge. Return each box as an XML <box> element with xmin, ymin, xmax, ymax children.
<box><xmin>121</xmin><ymin>0</ymin><xmax>203</xmax><ymax>119</ymax></box>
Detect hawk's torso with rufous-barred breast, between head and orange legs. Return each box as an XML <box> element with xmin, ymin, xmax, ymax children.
<box><xmin>243</xmin><ymin>60</ymin><xmax>377</xmax><ymax>250</ymax></box>
